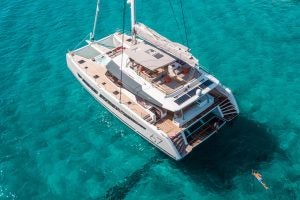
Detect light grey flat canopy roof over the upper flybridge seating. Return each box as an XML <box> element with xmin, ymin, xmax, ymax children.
<box><xmin>125</xmin><ymin>43</ymin><xmax>175</xmax><ymax>70</ymax></box>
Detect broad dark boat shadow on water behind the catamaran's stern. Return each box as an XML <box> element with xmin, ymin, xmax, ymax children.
<box><xmin>172</xmin><ymin>116</ymin><xmax>285</xmax><ymax>191</ymax></box>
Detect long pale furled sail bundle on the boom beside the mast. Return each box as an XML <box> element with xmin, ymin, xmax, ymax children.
<box><xmin>134</xmin><ymin>23</ymin><xmax>198</xmax><ymax>67</ymax></box>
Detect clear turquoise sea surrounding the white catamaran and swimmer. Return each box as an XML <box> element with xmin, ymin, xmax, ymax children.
<box><xmin>0</xmin><ymin>0</ymin><xmax>300</xmax><ymax>200</ymax></box>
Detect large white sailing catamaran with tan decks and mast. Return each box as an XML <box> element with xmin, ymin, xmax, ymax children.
<box><xmin>66</xmin><ymin>0</ymin><xmax>239</xmax><ymax>160</ymax></box>
